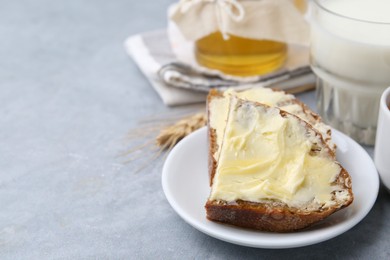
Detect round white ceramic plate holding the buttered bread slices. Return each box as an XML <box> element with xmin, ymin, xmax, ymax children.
<box><xmin>162</xmin><ymin>128</ymin><xmax>379</xmax><ymax>248</ymax></box>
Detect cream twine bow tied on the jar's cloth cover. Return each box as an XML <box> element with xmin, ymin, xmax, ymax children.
<box><xmin>178</xmin><ymin>0</ymin><xmax>245</xmax><ymax>40</ymax></box>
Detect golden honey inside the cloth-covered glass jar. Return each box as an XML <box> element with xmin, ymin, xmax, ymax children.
<box><xmin>195</xmin><ymin>0</ymin><xmax>306</xmax><ymax>76</ymax></box>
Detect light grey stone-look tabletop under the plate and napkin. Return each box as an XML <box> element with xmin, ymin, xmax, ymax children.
<box><xmin>0</xmin><ymin>0</ymin><xmax>390</xmax><ymax>259</ymax></box>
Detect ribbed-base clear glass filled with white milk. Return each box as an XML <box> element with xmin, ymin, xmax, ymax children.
<box><xmin>310</xmin><ymin>0</ymin><xmax>390</xmax><ymax>145</ymax></box>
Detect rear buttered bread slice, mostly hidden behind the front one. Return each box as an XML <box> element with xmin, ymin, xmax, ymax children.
<box><xmin>207</xmin><ymin>88</ymin><xmax>336</xmax><ymax>185</ymax></box>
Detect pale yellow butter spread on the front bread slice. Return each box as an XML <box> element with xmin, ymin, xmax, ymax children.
<box><xmin>210</xmin><ymin>99</ymin><xmax>347</xmax><ymax>207</ymax></box>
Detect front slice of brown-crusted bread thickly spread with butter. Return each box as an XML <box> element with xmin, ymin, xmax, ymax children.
<box><xmin>205</xmin><ymin>95</ymin><xmax>353</xmax><ymax>232</ymax></box>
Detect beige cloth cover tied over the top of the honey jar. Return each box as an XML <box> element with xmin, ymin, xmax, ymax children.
<box><xmin>169</xmin><ymin>0</ymin><xmax>309</xmax><ymax>46</ymax></box>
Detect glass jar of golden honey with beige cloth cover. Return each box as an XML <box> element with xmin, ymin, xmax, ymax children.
<box><xmin>173</xmin><ymin>0</ymin><xmax>307</xmax><ymax>77</ymax></box>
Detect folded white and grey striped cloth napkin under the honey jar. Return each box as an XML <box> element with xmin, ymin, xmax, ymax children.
<box><xmin>124</xmin><ymin>25</ymin><xmax>315</xmax><ymax>106</ymax></box>
